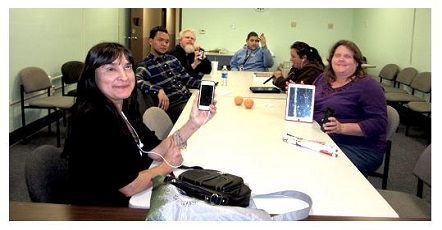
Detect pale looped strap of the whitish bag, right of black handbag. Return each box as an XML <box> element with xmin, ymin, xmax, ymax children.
<box><xmin>252</xmin><ymin>190</ymin><xmax>312</xmax><ymax>221</ymax></box>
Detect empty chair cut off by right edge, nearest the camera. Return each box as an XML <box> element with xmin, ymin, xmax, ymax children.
<box><xmin>378</xmin><ymin>144</ymin><xmax>431</xmax><ymax>218</ymax></box>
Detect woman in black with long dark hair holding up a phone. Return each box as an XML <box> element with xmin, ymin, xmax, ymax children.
<box><xmin>64</xmin><ymin>42</ymin><xmax>216</xmax><ymax>207</ymax></box>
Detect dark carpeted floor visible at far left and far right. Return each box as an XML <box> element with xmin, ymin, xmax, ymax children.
<box><xmin>9</xmin><ymin>121</ymin><xmax>431</xmax><ymax>202</ymax></box>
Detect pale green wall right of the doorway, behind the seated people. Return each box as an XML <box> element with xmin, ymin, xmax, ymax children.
<box><xmin>182</xmin><ymin>8</ymin><xmax>431</xmax><ymax>76</ymax></box>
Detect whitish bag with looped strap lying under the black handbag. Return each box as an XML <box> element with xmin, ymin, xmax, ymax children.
<box><xmin>146</xmin><ymin>176</ymin><xmax>312</xmax><ymax>221</ymax></box>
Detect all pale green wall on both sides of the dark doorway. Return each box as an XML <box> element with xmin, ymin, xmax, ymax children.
<box><xmin>9</xmin><ymin>8</ymin><xmax>431</xmax><ymax>132</ymax></box>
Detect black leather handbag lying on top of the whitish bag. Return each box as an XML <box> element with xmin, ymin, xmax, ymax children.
<box><xmin>164</xmin><ymin>169</ymin><xmax>252</xmax><ymax>207</ymax></box>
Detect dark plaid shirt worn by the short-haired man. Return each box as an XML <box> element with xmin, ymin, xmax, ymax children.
<box><xmin>136</xmin><ymin>53</ymin><xmax>201</xmax><ymax>104</ymax></box>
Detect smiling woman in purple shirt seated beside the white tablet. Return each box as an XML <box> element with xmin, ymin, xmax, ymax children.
<box><xmin>314</xmin><ymin>40</ymin><xmax>388</xmax><ymax>175</ymax></box>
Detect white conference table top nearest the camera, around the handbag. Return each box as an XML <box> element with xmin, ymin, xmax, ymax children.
<box><xmin>129</xmin><ymin>71</ymin><xmax>398</xmax><ymax>217</ymax></box>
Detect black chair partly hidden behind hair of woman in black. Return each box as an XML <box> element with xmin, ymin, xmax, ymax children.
<box><xmin>61</xmin><ymin>61</ymin><xmax>84</xmax><ymax>97</ymax></box>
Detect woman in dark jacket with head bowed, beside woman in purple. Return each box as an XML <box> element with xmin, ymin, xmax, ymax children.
<box><xmin>273</xmin><ymin>41</ymin><xmax>324</xmax><ymax>91</ymax></box>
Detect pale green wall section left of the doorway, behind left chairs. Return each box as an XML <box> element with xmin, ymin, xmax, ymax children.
<box><xmin>9</xmin><ymin>8</ymin><xmax>129</xmax><ymax>132</ymax></box>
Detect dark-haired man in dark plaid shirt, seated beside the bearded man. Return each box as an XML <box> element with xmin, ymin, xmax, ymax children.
<box><xmin>136</xmin><ymin>26</ymin><xmax>201</xmax><ymax>124</ymax></box>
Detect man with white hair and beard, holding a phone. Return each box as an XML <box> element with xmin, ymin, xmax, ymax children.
<box><xmin>169</xmin><ymin>29</ymin><xmax>212</xmax><ymax>79</ymax></box>
